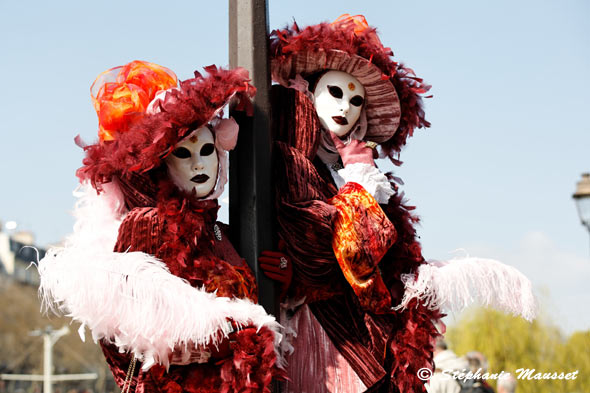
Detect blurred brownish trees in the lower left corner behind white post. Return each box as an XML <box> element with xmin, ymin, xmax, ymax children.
<box><xmin>0</xmin><ymin>277</ymin><xmax>115</xmax><ymax>393</ymax></box>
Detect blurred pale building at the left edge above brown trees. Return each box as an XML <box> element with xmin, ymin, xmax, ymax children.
<box><xmin>0</xmin><ymin>225</ymin><xmax>45</xmax><ymax>286</ymax></box>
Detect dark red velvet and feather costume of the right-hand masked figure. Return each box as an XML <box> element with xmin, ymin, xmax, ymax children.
<box><xmin>272</xmin><ymin>86</ymin><xmax>441</xmax><ymax>393</ymax></box>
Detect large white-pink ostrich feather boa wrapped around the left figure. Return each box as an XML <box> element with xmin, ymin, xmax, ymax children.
<box><xmin>38</xmin><ymin>184</ymin><xmax>284</xmax><ymax>370</ymax></box>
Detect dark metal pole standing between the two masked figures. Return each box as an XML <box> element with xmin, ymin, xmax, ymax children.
<box><xmin>229</xmin><ymin>0</ymin><xmax>279</xmax><ymax>315</ymax></box>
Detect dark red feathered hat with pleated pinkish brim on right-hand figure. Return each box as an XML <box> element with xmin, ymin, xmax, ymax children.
<box><xmin>270</xmin><ymin>14</ymin><xmax>430</xmax><ymax>157</ymax></box>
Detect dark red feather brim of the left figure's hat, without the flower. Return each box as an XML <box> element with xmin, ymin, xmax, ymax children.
<box><xmin>76</xmin><ymin>66</ymin><xmax>256</xmax><ymax>191</ymax></box>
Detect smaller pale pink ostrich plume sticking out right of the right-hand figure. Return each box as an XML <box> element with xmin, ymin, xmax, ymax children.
<box><xmin>396</xmin><ymin>257</ymin><xmax>536</xmax><ymax>321</ymax></box>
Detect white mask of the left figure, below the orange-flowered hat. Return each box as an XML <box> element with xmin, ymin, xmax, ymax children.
<box><xmin>166</xmin><ymin>127</ymin><xmax>219</xmax><ymax>198</ymax></box>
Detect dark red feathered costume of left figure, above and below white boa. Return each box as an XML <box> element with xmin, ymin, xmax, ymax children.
<box><xmin>100</xmin><ymin>177</ymin><xmax>279</xmax><ymax>393</ymax></box>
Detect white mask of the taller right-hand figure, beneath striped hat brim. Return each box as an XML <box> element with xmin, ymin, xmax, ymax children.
<box><xmin>313</xmin><ymin>71</ymin><xmax>365</xmax><ymax>137</ymax></box>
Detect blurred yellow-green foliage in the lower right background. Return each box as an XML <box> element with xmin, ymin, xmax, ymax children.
<box><xmin>446</xmin><ymin>309</ymin><xmax>590</xmax><ymax>393</ymax></box>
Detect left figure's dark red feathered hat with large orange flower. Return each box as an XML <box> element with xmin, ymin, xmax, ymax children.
<box><xmin>77</xmin><ymin>61</ymin><xmax>256</xmax><ymax>191</ymax></box>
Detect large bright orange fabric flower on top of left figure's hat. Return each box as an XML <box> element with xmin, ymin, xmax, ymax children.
<box><xmin>90</xmin><ymin>60</ymin><xmax>178</xmax><ymax>142</ymax></box>
